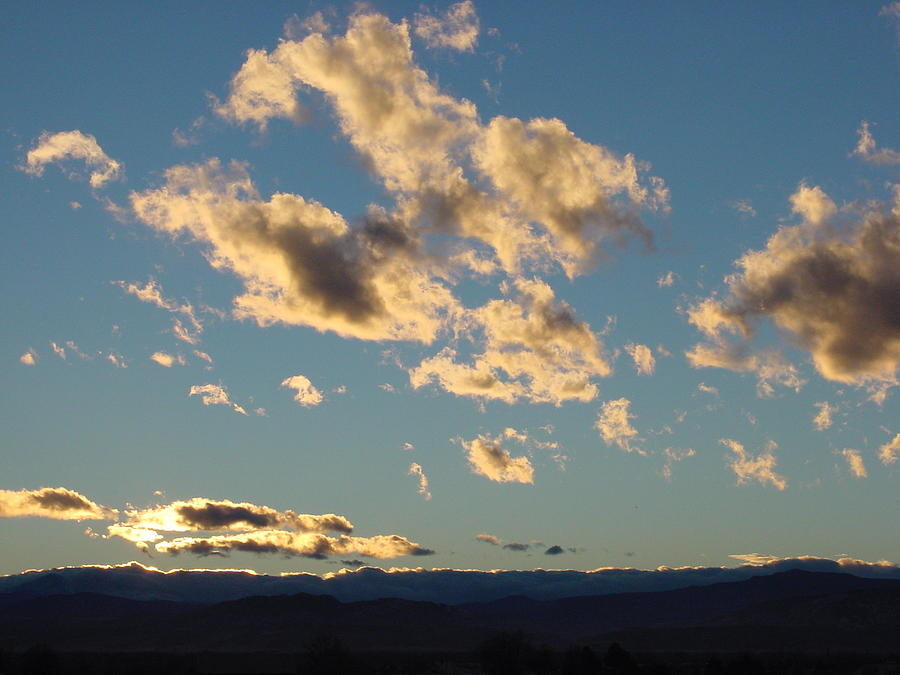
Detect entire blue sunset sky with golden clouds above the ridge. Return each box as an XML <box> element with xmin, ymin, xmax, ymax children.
<box><xmin>0</xmin><ymin>0</ymin><xmax>900</xmax><ymax>574</ymax></box>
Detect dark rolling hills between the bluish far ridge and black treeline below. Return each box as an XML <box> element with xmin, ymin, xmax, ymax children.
<box><xmin>0</xmin><ymin>570</ymin><xmax>900</xmax><ymax>651</ymax></box>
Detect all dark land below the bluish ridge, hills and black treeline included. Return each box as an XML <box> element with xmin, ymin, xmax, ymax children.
<box><xmin>0</xmin><ymin>570</ymin><xmax>900</xmax><ymax>675</ymax></box>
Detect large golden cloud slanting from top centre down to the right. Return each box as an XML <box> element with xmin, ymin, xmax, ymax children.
<box><xmin>211</xmin><ymin>3</ymin><xmax>668</xmax><ymax>280</ymax></box>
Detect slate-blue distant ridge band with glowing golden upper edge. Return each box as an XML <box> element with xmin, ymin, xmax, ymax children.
<box><xmin>0</xmin><ymin>558</ymin><xmax>900</xmax><ymax>605</ymax></box>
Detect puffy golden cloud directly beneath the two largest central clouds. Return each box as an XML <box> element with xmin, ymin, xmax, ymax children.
<box><xmin>409</xmin><ymin>278</ymin><xmax>611</xmax><ymax>406</ymax></box>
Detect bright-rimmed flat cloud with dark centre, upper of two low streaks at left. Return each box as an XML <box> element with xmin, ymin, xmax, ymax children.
<box><xmin>124</xmin><ymin>497</ymin><xmax>353</xmax><ymax>534</ymax></box>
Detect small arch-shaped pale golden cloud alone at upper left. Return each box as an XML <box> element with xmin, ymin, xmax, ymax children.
<box><xmin>22</xmin><ymin>130</ymin><xmax>123</xmax><ymax>188</ymax></box>
